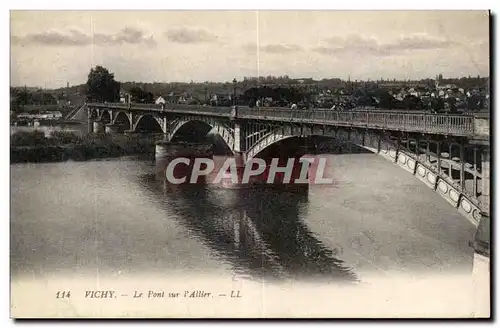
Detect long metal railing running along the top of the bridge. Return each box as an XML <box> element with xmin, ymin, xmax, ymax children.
<box><xmin>88</xmin><ymin>103</ymin><xmax>474</xmax><ymax>136</ymax></box>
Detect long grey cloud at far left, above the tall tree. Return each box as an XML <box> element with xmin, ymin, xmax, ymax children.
<box><xmin>11</xmin><ymin>27</ymin><xmax>156</xmax><ymax>46</ymax></box>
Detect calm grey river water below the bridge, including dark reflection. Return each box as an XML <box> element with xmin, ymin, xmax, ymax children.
<box><xmin>11</xmin><ymin>154</ymin><xmax>475</xmax><ymax>282</ymax></box>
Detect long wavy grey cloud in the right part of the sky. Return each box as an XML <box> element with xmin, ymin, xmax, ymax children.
<box><xmin>313</xmin><ymin>34</ymin><xmax>459</xmax><ymax>56</ymax></box>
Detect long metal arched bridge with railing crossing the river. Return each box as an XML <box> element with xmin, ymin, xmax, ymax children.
<box><xmin>86</xmin><ymin>103</ymin><xmax>490</xmax><ymax>242</ymax></box>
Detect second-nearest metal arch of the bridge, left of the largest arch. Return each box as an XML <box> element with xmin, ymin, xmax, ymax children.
<box><xmin>167</xmin><ymin>117</ymin><xmax>234</xmax><ymax>152</ymax></box>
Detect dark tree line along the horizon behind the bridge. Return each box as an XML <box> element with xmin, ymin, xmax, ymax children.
<box><xmin>11</xmin><ymin>66</ymin><xmax>489</xmax><ymax>111</ymax></box>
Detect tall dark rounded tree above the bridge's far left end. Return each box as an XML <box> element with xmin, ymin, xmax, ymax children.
<box><xmin>86</xmin><ymin>66</ymin><xmax>120</xmax><ymax>102</ymax></box>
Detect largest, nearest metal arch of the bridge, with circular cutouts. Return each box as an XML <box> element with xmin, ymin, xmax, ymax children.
<box><xmin>246</xmin><ymin>125</ymin><xmax>482</xmax><ymax>226</ymax></box>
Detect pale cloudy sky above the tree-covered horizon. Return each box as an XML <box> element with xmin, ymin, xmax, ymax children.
<box><xmin>10</xmin><ymin>11</ymin><xmax>489</xmax><ymax>88</ymax></box>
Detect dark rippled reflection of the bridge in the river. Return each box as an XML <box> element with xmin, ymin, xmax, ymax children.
<box><xmin>135</xmin><ymin>175</ymin><xmax>357</xmax><ymax>282</ymax></box>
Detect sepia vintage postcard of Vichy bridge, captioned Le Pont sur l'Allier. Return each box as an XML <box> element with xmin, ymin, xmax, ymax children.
<box><xmin>10</xmin><ymin>10</ymin><xmax>491</xmax><ymax>319</ymax></box>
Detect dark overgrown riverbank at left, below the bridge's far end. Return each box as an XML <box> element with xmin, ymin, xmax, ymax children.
<box><xmin>10</xmin><ymin>131</ymin><xmax>159</xmax><ymax>164</ymax></box>
